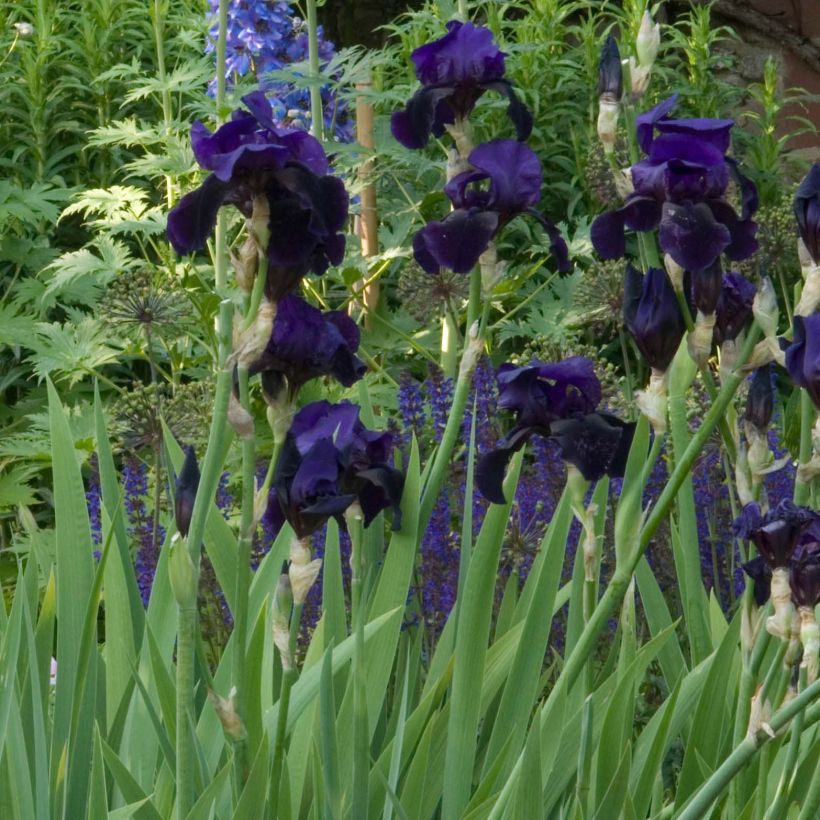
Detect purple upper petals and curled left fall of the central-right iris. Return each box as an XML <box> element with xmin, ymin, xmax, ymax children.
<box><xmin>476</xmin><ymin>356</ymin><xmax>601</xmax><ymax>504</ymax></box>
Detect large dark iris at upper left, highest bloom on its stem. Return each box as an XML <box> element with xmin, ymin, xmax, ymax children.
<box><xmin>168</xmin><ymin>91</ymin><xmax>348</xmax><ymax>300</ymax></box>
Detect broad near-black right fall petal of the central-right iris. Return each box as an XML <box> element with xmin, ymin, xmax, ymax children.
<box><xmin>550</xmin><ymin>413</ymin><xmax>635</xmax><ymax>481</ymax></box>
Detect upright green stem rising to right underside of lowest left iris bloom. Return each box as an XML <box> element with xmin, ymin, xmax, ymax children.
<box><xmin>346</xmin><ymin>505</ymin><xmax>370</xmax><ymax>820</ymax></box>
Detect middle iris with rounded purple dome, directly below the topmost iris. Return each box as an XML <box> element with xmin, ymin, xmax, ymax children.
<box><xmin>413</xmin><ymin>140</ymin><xmax>569</xmax><ymax>273</ymax></box>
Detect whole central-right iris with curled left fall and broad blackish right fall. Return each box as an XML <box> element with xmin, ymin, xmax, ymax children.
<box><xmin>476</xmin><ymin>356</ymin><xmax>634</xmax><ymax>504</ymax></box>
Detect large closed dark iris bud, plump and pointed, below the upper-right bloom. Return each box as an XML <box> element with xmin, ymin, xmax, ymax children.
<box><xmin>624</xmin><ymin>265</ymin><xmax>686</xmax><ymax>372</ymax></box>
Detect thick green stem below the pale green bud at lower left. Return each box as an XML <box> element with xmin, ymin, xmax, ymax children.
<box><xmin>176</xmin><ymin>606</ymin><xmax>196</xmax><ymax>820</ymax></box>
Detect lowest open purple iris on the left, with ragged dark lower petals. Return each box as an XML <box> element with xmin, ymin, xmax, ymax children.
<box><xmin>265</xmin><ymin>401</ymin><xmax>404</xmax><ymax>538</ymax></box>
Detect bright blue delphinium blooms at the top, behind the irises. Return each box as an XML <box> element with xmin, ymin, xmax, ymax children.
<box><xmin>206</xmin><ymin>0</ymin><xmax>353</xmax><ymax>142</ymax></box>
